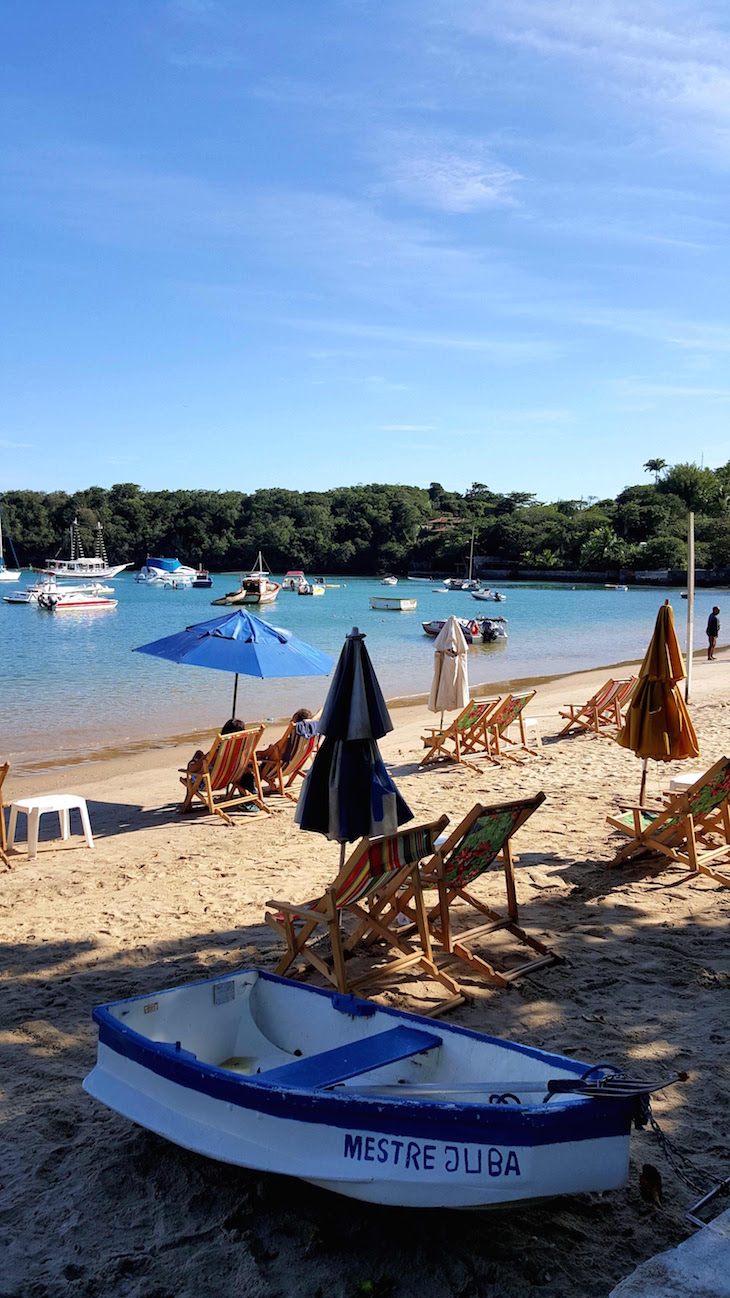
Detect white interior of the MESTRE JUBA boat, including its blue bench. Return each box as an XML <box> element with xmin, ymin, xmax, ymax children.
<box><xmin>105</xmin><ymin>970</ymin><xmax>585</xmax><ymax>1105</ymax></box>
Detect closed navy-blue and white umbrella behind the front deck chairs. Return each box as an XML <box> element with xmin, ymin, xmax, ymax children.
<box><xmin>295</xmin><ymin>627</ymin><xmax>413</xmax><ymax>859</ymax></box>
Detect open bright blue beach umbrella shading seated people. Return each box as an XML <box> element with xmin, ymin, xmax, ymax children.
<box><xmin>134</xmin><ymin>609</ymin><xmax>334</xmax><ymax>715</ymax></box>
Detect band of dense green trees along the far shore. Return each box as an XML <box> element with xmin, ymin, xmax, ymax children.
<box><xmin>1</xmin><ymin>459</ymin><xmax>730</xmax><ymax>574</ymax></box>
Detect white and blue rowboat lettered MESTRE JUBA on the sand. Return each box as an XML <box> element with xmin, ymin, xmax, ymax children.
<box><xmin>83</xmin><ymin>970</ymin><xmax>666</xmax><ymax>1207</ymax></box>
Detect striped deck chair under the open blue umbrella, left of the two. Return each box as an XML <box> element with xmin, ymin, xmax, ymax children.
<box><xmin>179</xmin><ymin>726</ymin><xmax>270</xmax><ymax>824</ymax></box>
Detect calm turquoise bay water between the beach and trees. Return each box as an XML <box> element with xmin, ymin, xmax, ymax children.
<box><xmin>0</xmin><ymin>572</ymin><xmax>717</xmax><ymax>771</ymax></box>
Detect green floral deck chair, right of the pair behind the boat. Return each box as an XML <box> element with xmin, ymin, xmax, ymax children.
<box><xmin>361</xmin><ymin>793</ymin><xmax>561</xmax><ymax>986</ymax></box>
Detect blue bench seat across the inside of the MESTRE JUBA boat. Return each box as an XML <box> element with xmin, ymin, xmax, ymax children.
<box><xmin>258</xmin><ymin>1025</ymin><xmax>442</xmax><ymax>1090</ymax></box>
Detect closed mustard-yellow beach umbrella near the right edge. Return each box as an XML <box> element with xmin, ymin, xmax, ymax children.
<box><xmin>617</xmin><ymin>600</ymin><xmax>700</xmax><ymax>803</ymax></box>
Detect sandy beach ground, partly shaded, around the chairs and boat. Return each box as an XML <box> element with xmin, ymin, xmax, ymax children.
<box><xmin>0</xmin><ymin>650</ymin><xmax>730</xmax><ymax>1298</ymax></box>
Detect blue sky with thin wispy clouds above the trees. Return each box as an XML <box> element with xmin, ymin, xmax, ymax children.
<box><xmin>0</xmin><ymin>0</ymin><xmax>730</xmax><ymax>500</ymax></box>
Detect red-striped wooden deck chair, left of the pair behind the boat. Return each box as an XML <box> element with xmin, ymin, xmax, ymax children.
<box><xmin>264</xmin><ymin>816</ymin><xmax>464</xmax><ymax>1011</ymax></box>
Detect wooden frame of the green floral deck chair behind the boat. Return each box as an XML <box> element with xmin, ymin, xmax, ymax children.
<box><xmin>361</xmin><ymin>793</ymin><xmax>561</xmax><ymax>986</ymax></box>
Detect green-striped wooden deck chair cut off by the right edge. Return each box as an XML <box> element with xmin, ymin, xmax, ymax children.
<box><xmin>607</xmin><ymin>757</ymin><xmax>730</xmax><ymax>888</ymax></box>
